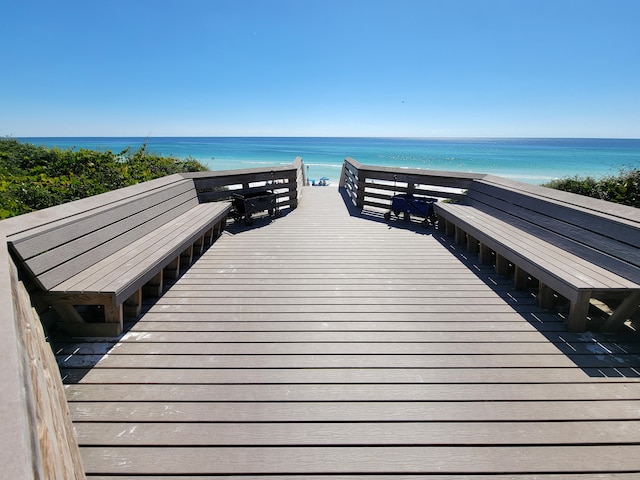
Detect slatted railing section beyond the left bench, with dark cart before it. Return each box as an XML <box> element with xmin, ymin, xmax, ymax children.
<box><xmin>184</xmin><ymin>157</ymin><xmax>306</xmax><ymax>208</ymax></box>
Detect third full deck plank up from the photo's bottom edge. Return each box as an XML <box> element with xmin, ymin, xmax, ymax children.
<box><xmin>66</xmin><ymin>400</ymin><xmax>638</xmax><ymax>422</ymax></box>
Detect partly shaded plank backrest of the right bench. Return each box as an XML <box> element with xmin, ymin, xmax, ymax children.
<box><xmin>466</xmin><ymin>176</ymin><xmax>640</xmax><ymax>283</ymax></box>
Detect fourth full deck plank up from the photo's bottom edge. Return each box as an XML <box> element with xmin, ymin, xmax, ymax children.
<box><xmin>67</xmin><ymin>382</ymin><xmax>637</xmax><ymax>402</ymax></box>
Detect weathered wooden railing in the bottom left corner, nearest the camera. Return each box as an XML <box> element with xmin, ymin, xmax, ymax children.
<box><xmin>0</xmin><ymin>238</ymin><xmax>85</xmax><ymax>479</ymax></box>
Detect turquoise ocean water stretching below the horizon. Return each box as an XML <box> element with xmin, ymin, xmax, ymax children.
<box><xmin>20</xmin><ymin>137</ymin><xmax>640</xmax><ymax>184</ymax></box>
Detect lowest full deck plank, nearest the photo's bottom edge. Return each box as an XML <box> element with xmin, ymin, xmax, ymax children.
<box><xmin>76</xmin><ymin>445</ymin><xmax>638</xmax><ymax>475</ymax></box>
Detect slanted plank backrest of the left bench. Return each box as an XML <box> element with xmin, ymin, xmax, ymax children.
<box><xmin>8</xmin><ymin>175</ymin><xmax>198</xmax><ymax>290</ymax></box>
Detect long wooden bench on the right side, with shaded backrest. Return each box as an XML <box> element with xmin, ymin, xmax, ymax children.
<box><xmin>435</xmin><ymin>176</ymin><xmax>640</xmax><ymax>332</ymax></box>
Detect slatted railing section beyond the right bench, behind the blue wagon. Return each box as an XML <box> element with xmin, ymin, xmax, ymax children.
<box><xmin>340</xmin><ymin>158</ymin><xmax>485</xmax><ymax>209</ymax></box>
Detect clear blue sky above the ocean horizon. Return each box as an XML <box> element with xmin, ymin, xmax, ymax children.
<box><xmin>0</xmin><ymin>0</ymin><xmax>640</xmax><ymax>138</ymax></box>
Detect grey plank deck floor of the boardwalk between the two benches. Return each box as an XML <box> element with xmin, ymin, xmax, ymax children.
<box><xmin>58</xmin><ymin>187</ymin><xmax>640</xmax><ymax>480</ymax></box>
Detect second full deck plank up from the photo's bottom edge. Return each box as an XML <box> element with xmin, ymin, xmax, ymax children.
<box><xmin>76</xmin><ymin>420</ymin><xmax>640</xmax><ymax>446</ymax></box>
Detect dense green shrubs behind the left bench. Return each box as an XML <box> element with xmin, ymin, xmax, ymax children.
<box><xmin>0</xmin><ymin>138</ymin><xmax>206</xmax><ymax>219</ymax></box>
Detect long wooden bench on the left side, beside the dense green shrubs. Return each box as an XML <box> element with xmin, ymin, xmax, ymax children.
<box><xmin>7</xmin><ymin>175</ymin><xmax>231</xmax><ymax>336</ymax></box>
